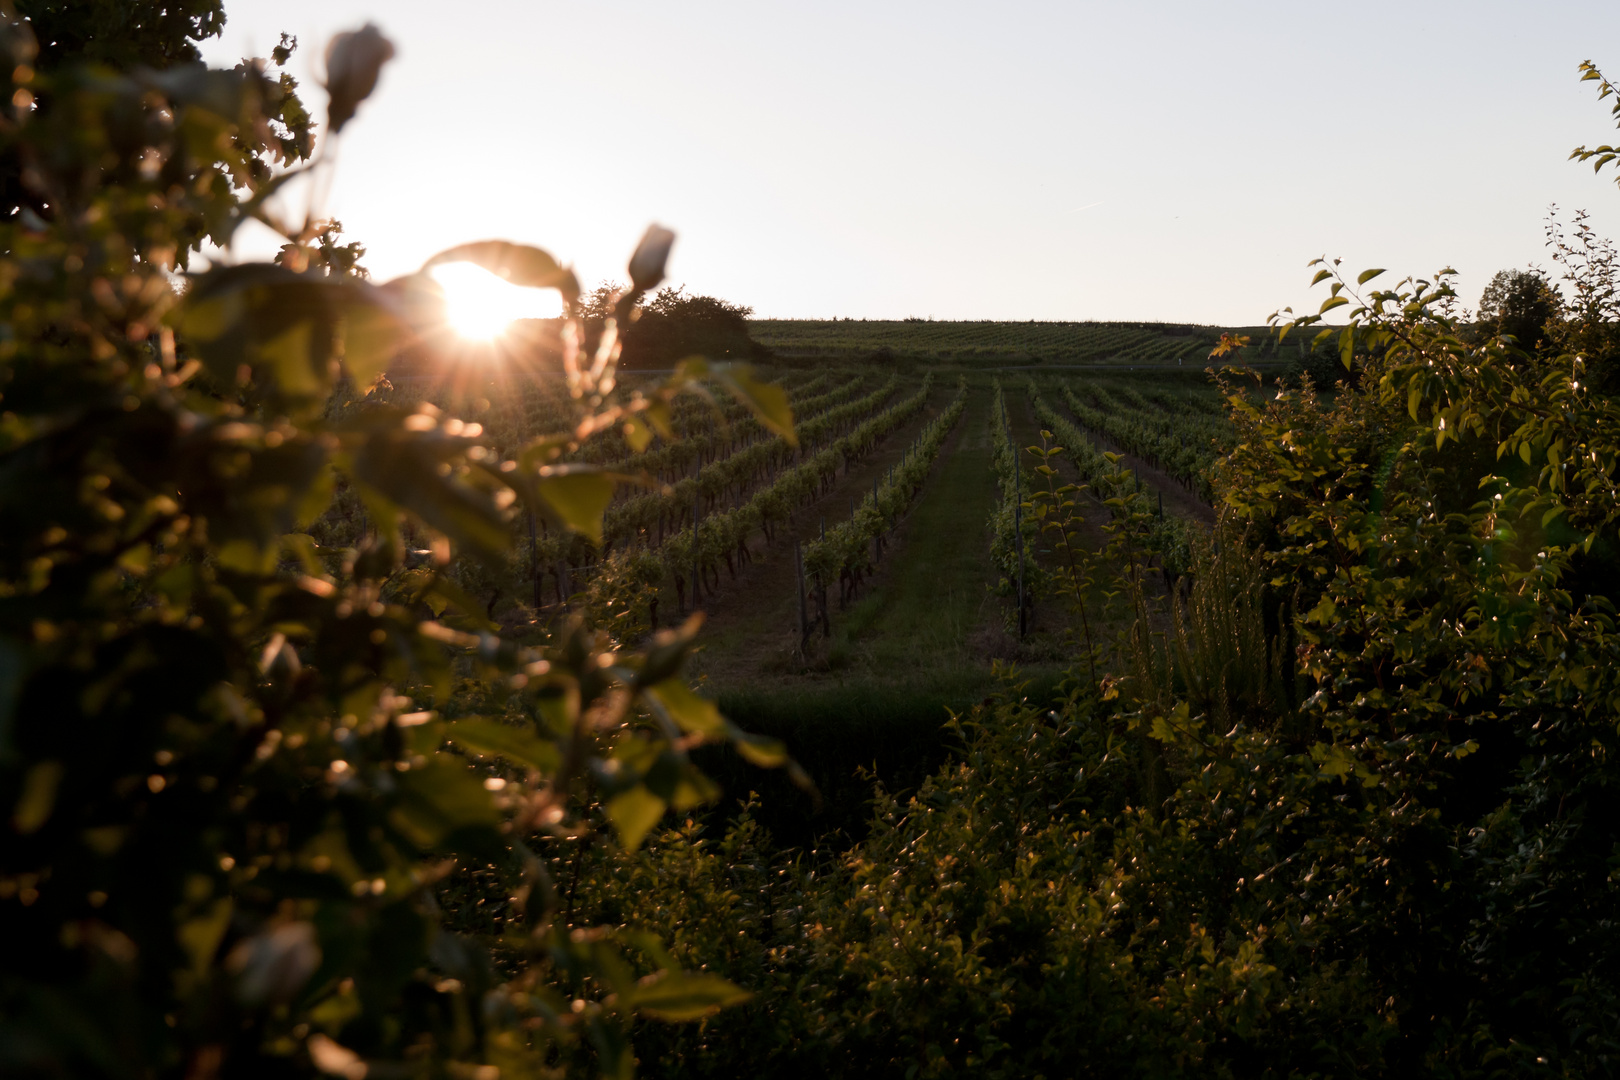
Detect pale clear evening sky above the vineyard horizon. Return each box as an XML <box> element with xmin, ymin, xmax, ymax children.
<box><xmin>204</xmin><ymin>0</ymin><xmax>1620</xmax><ymax>325</ymax></box>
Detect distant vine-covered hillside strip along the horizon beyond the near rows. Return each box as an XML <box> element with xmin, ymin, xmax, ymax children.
<box><xmin>748</xmin><ymin>319</ymin><xmax>1296</xmax><ymax>366</ymax></box>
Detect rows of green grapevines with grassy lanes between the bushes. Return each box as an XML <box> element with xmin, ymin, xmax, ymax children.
<box><xmin>358</xmin><ymin>362</ymin><xmax>1231</xmax><ymax>702</ymax></box>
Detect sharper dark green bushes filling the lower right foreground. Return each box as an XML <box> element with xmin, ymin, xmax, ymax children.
<box><xmin>502</xmin><ymin>250</ymin><xmax>1620</xmax><ymax>1077</ymax></box>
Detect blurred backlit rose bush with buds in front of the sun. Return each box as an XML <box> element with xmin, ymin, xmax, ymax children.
<box><xmin>0</xmin><ymin>5</ymin><xmax>791</xmax><ymax>1077</ymax></box>
